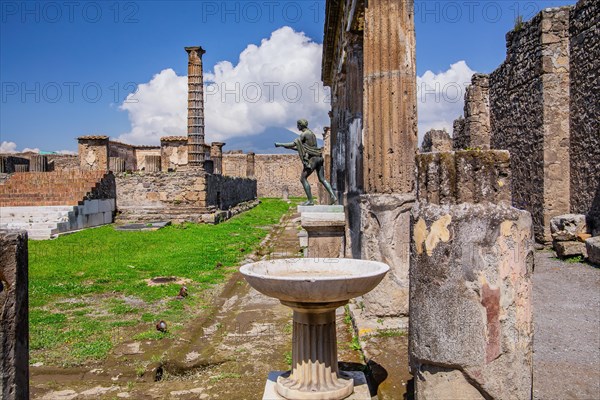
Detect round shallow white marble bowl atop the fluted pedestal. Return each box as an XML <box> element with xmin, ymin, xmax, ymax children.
<box><xmin>240</xmin><ymin>258</ymin><xmax>390</xmax><ymax>303</ymax></box>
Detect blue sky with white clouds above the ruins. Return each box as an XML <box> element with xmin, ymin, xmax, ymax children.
<box><xmin>0</xmin><ymin>0</ymin><xmax>575</xmax><ymax>151</ymax></box>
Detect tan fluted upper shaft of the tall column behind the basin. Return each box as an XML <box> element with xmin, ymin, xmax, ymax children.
<box><xmin>364</xmin><ymin>0</ymin><xmax>417</xmax><ymax>193</ymax></box>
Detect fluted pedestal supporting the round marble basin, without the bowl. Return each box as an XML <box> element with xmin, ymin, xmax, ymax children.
<box><xmin>275</xmin><ymin>301</ymin><xmax>354</xmax><ymax>400</ymax></box>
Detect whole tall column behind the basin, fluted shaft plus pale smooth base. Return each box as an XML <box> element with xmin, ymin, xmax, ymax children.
<box><xmin>358</xmin><ymin>0</ymin><xmax>417</xmax><ymax>319</ymax></box>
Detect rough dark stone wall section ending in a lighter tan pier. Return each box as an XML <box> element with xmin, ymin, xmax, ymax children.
<box><xmin>489</xmin><ymin>7</ymin><xmax>570</xmax><ymax>241</ymax></box>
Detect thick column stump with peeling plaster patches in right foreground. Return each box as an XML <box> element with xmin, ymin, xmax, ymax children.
<box><xmin>409</xmin><ymin>203</ymin><xmax>534</xmax><ymax>400</ymax></box>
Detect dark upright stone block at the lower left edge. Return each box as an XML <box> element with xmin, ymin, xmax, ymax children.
<box><xmin>0</xmin><ymin>230</ymin><xmax>29</xmax><ymax>400</ymax></box>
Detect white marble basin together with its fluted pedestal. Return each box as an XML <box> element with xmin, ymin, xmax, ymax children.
<box><xmin>240</xmin><ymin>258</ymin><xmax>390</xmax><ymax>400</ymax></box>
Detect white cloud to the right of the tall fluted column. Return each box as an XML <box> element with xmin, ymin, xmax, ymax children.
<box><xmin>417</xmin><ymin>61</ymin><xmax>475</xmax><ymax>143</ymax></box>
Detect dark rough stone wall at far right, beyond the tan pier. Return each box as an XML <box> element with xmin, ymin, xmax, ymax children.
<box><xmin>569</xmin><ymin>0</ymin><xmax>600</xmax><ymax>231</ymax></box>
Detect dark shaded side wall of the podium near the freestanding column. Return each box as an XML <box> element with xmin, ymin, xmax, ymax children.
<box><xmin>206</xmin><ymin>175</ymin><xmax>256</xmax><ymax>210</ymax></box>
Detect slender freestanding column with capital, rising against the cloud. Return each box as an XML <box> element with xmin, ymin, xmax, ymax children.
<box><xmin>185</xmin><ymin>46</ymin><xmax>205</xmax><ymax>169</ymax></box>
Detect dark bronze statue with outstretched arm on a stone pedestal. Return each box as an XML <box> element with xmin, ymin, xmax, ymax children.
<box><xmin>275</xmin><ymin>119</ymin><xmax>337</xmax><ymax>205</ymax></box>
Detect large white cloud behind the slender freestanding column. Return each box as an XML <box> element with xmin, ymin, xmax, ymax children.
<box><xmin>119</xmin><ymin>27</ymin><xmax>330</xmax><ymax>144</ymax></box>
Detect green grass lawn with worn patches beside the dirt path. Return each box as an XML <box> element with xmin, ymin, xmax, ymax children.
<box><xmin>29</xmin><ymin>199</ymin><xmax>295</xmax><ymax>366</ymax></box>
